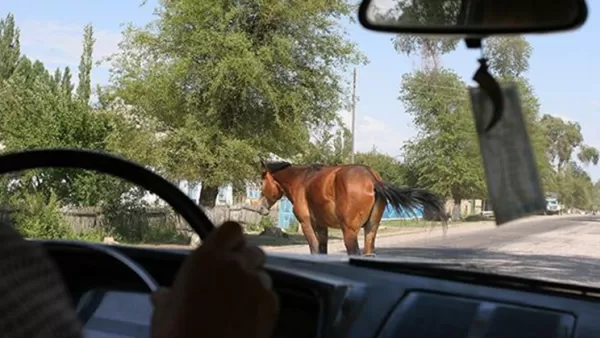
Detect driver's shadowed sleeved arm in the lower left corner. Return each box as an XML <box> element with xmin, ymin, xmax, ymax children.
<box><xmin>0</xmin><ymin>222</ymin><xmax>83</xmax><ymax>338</ymax></box>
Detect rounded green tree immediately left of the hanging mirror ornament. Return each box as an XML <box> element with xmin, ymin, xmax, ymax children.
<box><xmin>400</xmin><ymin>68</ymin><xmax>486</xmax><ymax>217</ymax></box>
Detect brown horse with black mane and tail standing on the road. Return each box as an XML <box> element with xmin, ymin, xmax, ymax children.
<box><xmin>258</xmin><ymin>161</ymin><xmax>447</xmax><ymax>256</ymax></box>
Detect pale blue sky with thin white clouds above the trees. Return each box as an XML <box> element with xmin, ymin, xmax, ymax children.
<box><xmin>0</xmin><ymin>0</ymin><xmax>600</xmax><ymax>180</ymax></box>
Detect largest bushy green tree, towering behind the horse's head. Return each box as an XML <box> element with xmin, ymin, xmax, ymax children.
<box><xmin>107</xmin><ymin>0</ymin><xmax>364</xmax><ymax>207</ymax></box>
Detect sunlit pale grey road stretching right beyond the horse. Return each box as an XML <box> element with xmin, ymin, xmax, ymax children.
<box><xmin>265</xmin><ymin>215</ymin><xmax>600</xmax><ymax>287</ymax></box>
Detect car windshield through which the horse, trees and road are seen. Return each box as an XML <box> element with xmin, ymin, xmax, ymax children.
<box><xmin>0</xmin><ymin>0</ymin><xmax>600</xmax><ymax>285</ymax></box>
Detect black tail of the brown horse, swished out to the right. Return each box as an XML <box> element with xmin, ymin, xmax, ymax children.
<box><xmin>374</xmin><ymin>180</ymin><xmax>446</xmax><ymax>221</ymax></box>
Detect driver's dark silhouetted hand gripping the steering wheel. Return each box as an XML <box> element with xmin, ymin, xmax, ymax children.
<box><xmin>151</xmin><ymin>222</ymin><xmax>278</xmax><ymax>338</ymax></box>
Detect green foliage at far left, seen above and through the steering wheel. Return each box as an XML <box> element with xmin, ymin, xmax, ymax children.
<box><xmin>0</xmin><ymin>14</ymin><xmax>180</xmax><ymax>240</ymax></box>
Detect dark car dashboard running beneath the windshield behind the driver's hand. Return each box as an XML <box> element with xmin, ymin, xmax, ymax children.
<box><xmin>44</xmin><ymin>242</ymin><xmax>600</xmax><ymax>338</ymax></box>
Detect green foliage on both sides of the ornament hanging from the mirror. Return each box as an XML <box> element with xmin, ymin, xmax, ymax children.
<box><xmin>400</xmin><ymin>33</ymin><xmax>600</xmax><ymax>208</ymax></box>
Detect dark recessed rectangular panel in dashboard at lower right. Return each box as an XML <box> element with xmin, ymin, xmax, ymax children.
<box><xmin>381</xmin><ymin>292</ymin><xmax>575</xmax><ymax>338</ymax></box>
